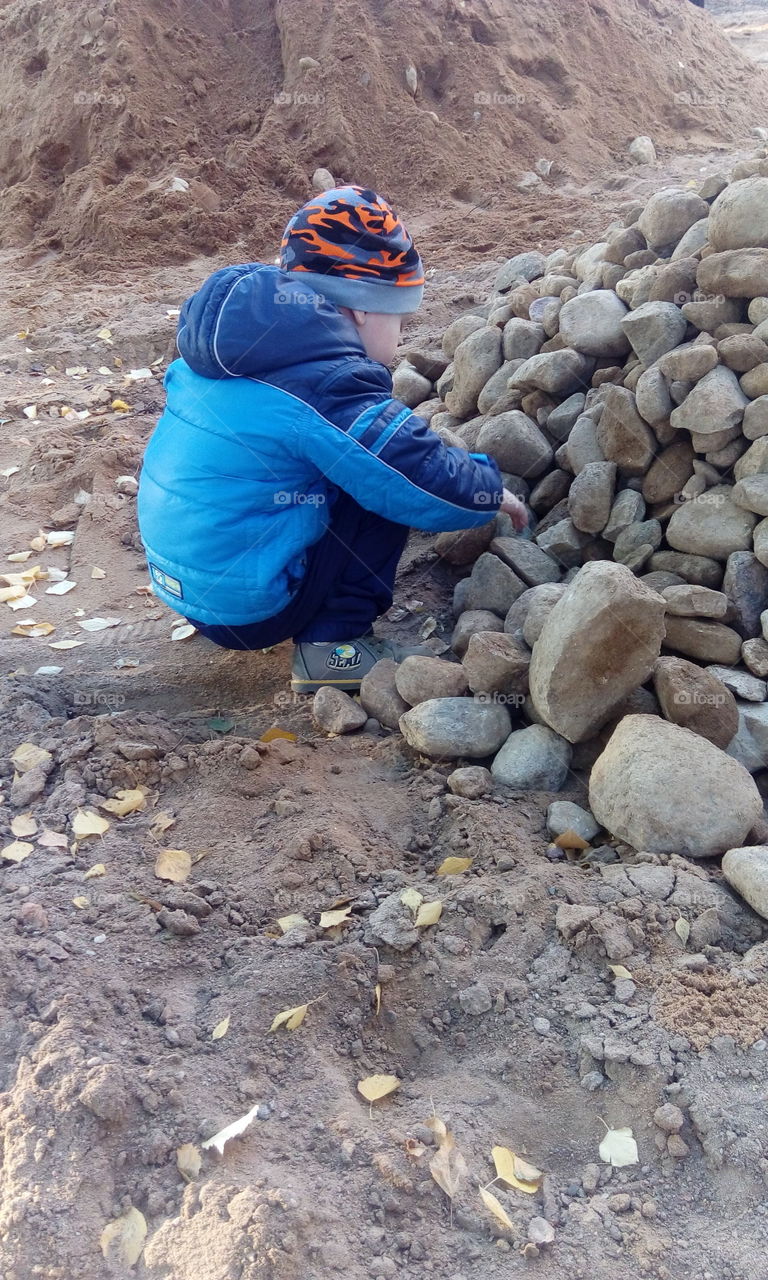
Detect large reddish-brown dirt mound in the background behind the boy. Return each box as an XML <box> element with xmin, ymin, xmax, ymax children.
<box><xmin>0</xmin><ymin>0</ymin><xmax>765</xmax><ymax>271</ymax></box>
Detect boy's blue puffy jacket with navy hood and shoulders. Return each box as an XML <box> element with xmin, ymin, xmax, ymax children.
<box><xmin>138</xmin><ymin>262</ymin><xmax>502</xmax><ymax>626</ymax></box>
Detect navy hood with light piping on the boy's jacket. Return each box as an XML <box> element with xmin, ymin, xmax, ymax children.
<box><xmin>177</xmin><ymin>262</ymin><xmax>366</xmax><ymax>378</ymax></box>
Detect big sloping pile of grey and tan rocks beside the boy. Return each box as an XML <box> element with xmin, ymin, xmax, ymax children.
<box><xmin>316</xmin><ymin>157</ymin><xmax>768</xmax><ymax>880</ymax></box>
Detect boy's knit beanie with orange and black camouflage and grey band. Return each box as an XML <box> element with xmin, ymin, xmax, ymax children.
<box><xmin>280</xmin><ymin>187</ymin><xmax>424</xmax><ymax>315</ymax></box>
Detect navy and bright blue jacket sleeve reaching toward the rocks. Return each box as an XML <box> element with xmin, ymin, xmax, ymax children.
<box><xmin>289</xmin><ymin>358</ymin><xmax>503</xmax><ymax>531</ymax></box>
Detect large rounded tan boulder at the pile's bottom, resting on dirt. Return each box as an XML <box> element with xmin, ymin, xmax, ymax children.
<box><xmin>589</xmin><ymin>716</ymin><xmax>763</xmax><ymax>859</ymax></box>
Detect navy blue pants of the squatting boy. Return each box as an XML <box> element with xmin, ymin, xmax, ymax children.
<box><xmin>188</xmin><ymin>489</ymin><xmax>408</xmax><ymax>649</ymax></box>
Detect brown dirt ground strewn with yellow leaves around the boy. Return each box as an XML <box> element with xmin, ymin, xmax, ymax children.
<box><xmin>0</xmin><ymin>5</ymin><xmax>768</xmax><ymax>1280</ymax></box>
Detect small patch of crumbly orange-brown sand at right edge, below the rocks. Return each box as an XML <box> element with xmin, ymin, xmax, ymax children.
<box><xmin>652</xmin><ymin>969</ymin><xmax>768</xmax><ymax>1050</ymax></box>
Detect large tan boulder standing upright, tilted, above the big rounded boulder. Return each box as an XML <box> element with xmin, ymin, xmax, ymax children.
<box><xmin>530</xmin><ymin>561</ymin><xmax>664</xmax><ymax>742</ymax></box>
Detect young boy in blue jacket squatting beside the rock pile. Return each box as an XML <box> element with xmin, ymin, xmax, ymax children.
<box><xmin>138</xmin><ymin>187</ymin><xmax>527</xmax><ymax>692</ymax></box>
